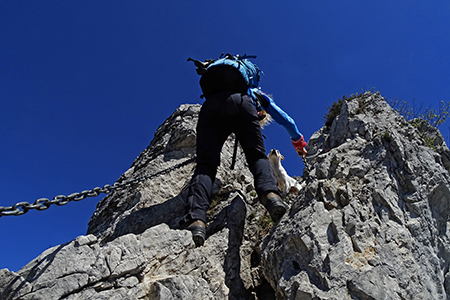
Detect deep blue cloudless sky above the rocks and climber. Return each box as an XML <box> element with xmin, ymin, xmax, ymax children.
<box><xmin>0</xmin><ymin>0</ymin><xmax>450</xmax><ymax>271</ymax></box>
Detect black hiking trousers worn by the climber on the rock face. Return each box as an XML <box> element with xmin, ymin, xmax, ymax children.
<box><xmin>183</xmin><ymin>92</ymin><xmax>278</xmax><ymax>223</ymax></box>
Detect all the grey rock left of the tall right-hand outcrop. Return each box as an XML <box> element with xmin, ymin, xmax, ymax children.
<box><xmin>0</xmin><ymin>105</ymin><xmax>274</xmax><ymax>299</ymax></box>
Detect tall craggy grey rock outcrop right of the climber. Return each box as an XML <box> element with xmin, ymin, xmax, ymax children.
<box><xmin>262</xmin><ymin>93</ymin><xmax>450</xmax><ymax>299</ymax></box>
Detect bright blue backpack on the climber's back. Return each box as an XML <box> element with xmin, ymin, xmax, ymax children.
<box><xmin>188</xmin><ymin>54</ymin><xmax>261</xmax><ymax>88</ymax></box>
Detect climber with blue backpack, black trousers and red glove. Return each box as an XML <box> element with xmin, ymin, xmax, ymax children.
<box><xmin>180</xmin><ymin>54</ymin><xmax>307</xmax><ymax>247</ymax></box>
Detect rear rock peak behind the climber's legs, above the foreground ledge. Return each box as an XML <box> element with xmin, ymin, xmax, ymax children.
<box><xmin>88</xmin><ymin>105</ymin><xmax>254</xmax><ymax>244</ymax></box>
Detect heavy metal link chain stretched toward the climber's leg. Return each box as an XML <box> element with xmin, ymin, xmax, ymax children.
<box><xmin>0</xmin><ymin>156</ymin><xmax>196</xmax><ymax>217</ymax></box>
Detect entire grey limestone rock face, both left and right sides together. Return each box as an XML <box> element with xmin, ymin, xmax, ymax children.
<box><xmin>0</xmin><ymin>93</ymin><xmax>450</xmax><ymax>300</ymax></box>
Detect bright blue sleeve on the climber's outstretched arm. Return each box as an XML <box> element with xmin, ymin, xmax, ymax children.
<box><xmin>248</xmin><ymin>88</ymin><xmax>302</xmax><ymax>141</ymax></box>
